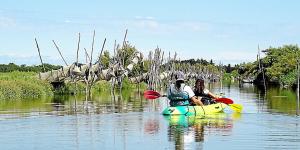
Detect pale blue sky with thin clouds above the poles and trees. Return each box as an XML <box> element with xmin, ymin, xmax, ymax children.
<box><xmin>0</xmin><ymin>0</ymin><xmax>300</xmax><ymax>64</ymax></box>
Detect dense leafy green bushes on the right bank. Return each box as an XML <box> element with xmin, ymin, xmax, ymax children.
<box><xmin>231</xmin><ymin>45</ymin><xmax>300</xmax><ymax>86</ymax></box>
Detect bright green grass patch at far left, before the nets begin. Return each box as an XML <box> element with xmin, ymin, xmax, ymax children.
<box><xmin>0</xmin><ymin>71</ymin><xmax>53</xmax><ymax>99</ymax></box>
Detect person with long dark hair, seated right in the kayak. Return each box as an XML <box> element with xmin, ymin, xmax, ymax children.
<box><xmin>194</xmin><ymin>78</ymin><xmax>219</xmax><ymax>105</ymax></box>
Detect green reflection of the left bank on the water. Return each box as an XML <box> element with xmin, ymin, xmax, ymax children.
<box><xmin>0</xmin><ymin>90</ymin><xmax>147</xmax><ymax>116</ymax></box>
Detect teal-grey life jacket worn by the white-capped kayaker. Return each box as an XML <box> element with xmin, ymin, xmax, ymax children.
<box><xmin>168</xmin><ymin>85</ymin><xmax>190</xmax><ymax>107</ymax></box>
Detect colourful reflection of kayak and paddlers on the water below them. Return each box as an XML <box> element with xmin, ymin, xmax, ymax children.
<box><xmin>165</xmin><ymin>113</ymin><xmax>240</xmax><ymax>150</ymax></box>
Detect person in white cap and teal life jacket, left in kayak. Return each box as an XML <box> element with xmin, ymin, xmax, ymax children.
<box><xmin>167</xmin><ymin>71</ymin><xmax>203</xmax><ymax>106</ymax></box>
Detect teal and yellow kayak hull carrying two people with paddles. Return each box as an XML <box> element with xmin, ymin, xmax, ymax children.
<box><xmin>162</xmin><ymin>103</ymin><xmax>227</xmax><ymax>116</ymax></box>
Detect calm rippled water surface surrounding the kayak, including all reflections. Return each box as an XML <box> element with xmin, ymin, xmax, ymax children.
<box><xmin>0</xmin><ymin>84</ymin><xmax>300</xmax><ymax>150</ymax></box>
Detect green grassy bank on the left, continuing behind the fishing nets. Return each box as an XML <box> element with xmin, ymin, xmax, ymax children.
<box><xmin>0</xmin><ymin>71</ymin><xmax>146</xmax><ymax>100</ymax></box>
